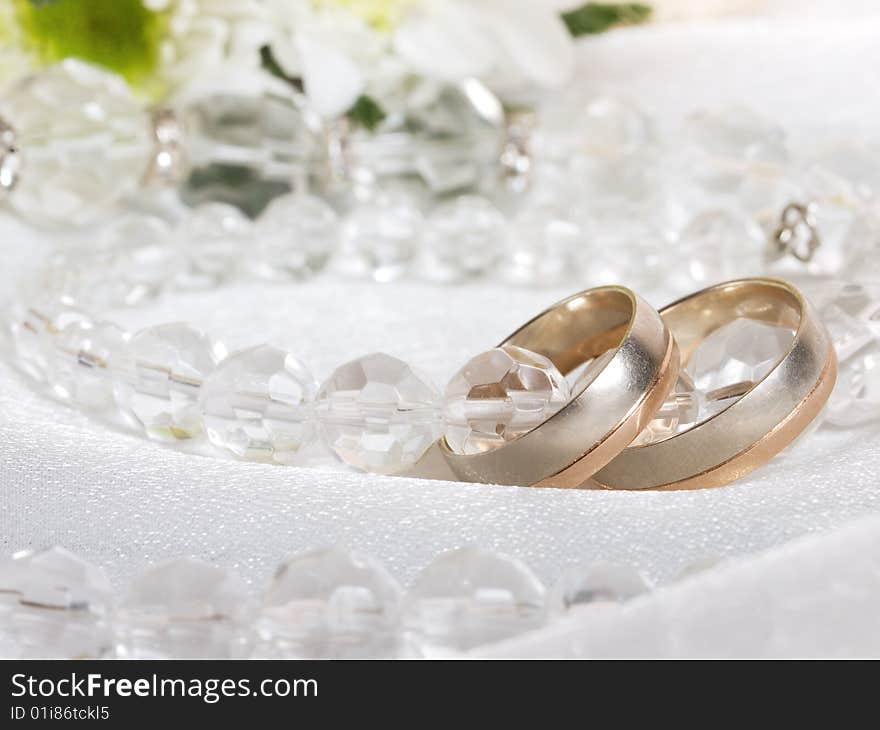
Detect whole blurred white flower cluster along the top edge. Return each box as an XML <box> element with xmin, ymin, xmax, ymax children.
<box><xmin>154</xmin><ymin>0</ymin><xmax>574</xmax><ymax>118</ymax></box>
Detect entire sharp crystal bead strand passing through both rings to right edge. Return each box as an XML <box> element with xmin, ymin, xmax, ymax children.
<box><xmin>8</xmin><ymin>268</ymin><xmax>880</xmax><ymax>474</ymax></box>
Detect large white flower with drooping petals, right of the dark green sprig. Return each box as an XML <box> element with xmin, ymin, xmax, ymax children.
<box><xmin>268</xmin><ymin>0</ymin><xmax>574</xmax><ymax>117</ymax></box>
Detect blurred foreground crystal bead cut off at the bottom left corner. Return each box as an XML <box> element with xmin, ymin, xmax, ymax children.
<box><xmin>0</xmin><ymin>547</ymin><xmax>113</xmax><ymax>659</ymax></box>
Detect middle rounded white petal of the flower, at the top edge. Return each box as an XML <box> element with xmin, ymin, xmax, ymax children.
<box><xmin>394</xmin><ymin>3</ymin><xmax>497</xmax><ymax>81</ymax></box>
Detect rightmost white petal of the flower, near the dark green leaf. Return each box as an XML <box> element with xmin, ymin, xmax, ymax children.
<box><xmin>479</xmin><ymin>0</ymin><xmax>574</xmax><ymax>88</ymax></box>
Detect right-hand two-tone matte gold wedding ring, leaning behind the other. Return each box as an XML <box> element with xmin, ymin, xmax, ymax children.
<box><xmin>591</xmin><ymin>279</ymin><xmax>837</xmax><ymax>490</ymax></box>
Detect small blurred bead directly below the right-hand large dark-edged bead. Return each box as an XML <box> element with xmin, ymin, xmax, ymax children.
<box><xmin>422</xmin><ymin>195</ymin><xmax>505</xmax><ymax>281</ymax></box>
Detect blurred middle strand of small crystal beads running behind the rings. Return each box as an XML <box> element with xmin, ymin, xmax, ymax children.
<box><xmin>0</xmin><ymin>140</ymin><xmax>880</xmax><ymax>292</ymax></box>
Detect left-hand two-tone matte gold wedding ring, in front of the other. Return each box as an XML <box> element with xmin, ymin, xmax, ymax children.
<box><xmin>403</xmin><ymin>286</ymin><xmax>680</xmax><ymax>488</ymax></box>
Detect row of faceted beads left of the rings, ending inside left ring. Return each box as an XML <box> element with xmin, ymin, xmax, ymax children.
<box><xmin>9</xmin><ymin>262</ymin><xmax>604</xmax><ymax>474</ymax></box>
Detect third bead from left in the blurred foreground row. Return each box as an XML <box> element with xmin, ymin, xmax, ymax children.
<box><xmin>256</xmin><ymin>548</ymin><xmax>403</xmax><ymax>658</ymax></box>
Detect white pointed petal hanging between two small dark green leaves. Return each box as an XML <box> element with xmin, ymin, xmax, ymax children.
<box><xmin>297</xmin><ymin>36</ymin><xmax>364</xmax><ymax>118</ymax></box>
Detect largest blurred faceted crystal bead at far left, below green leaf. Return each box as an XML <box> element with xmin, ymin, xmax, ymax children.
<box><xmin>0</xmin><ymin>59</ymin><xmax>152</xmax><ymax>226</ymax></box>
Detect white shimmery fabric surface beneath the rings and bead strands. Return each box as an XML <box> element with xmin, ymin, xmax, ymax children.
<box><xmin>0</xmin><ymin>8</ymin><xmax>880</xmax><ymax>652</ymax></box>
